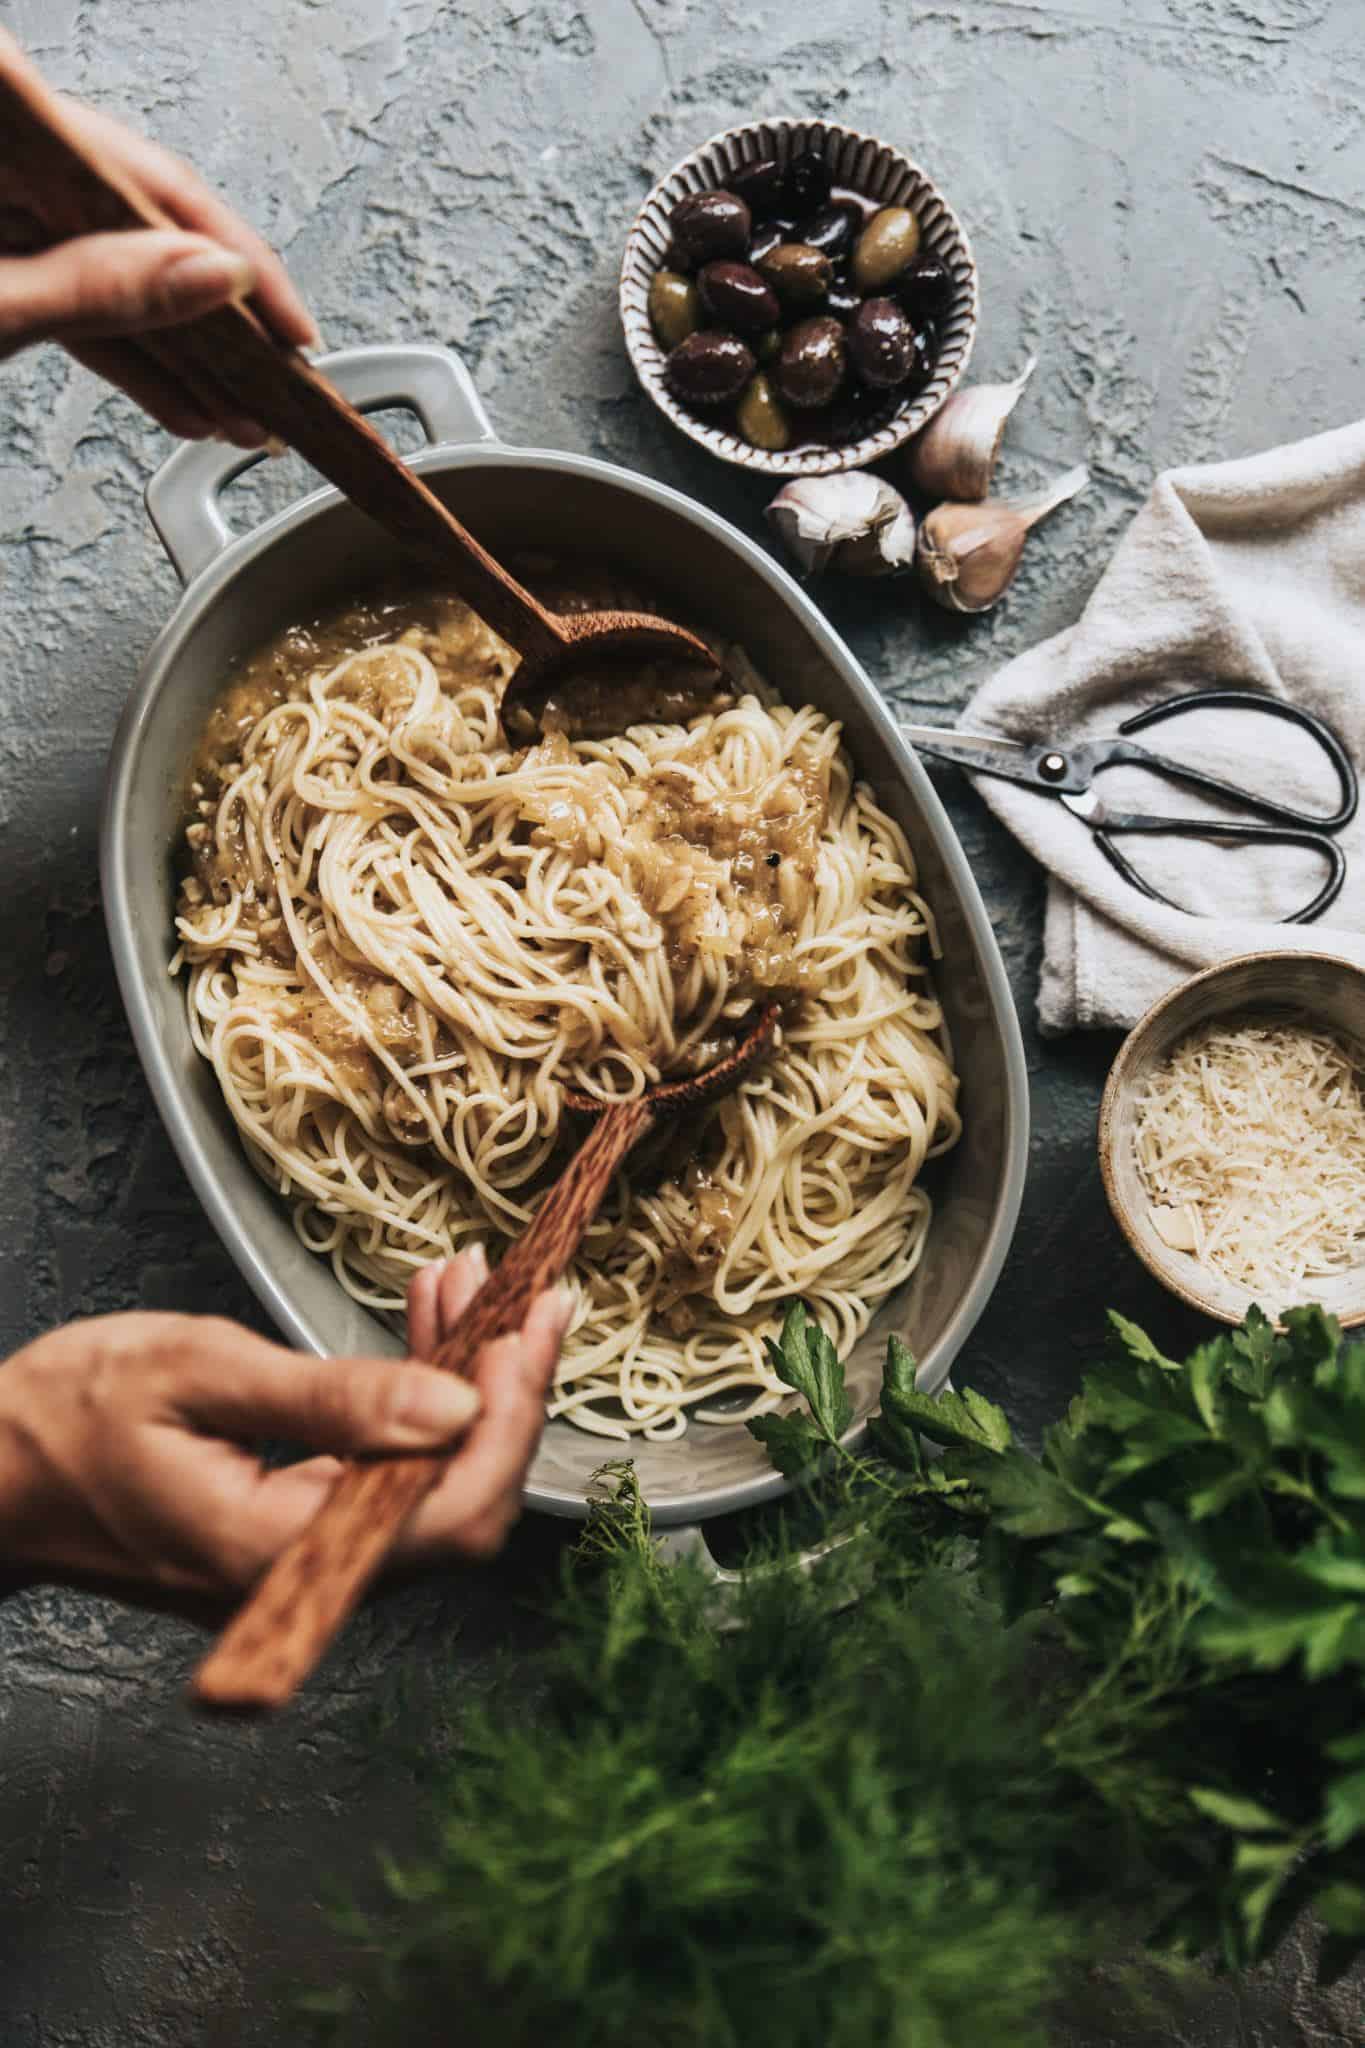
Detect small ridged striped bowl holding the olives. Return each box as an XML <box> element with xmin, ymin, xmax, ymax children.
<box><xmin>620</xmin><ymin>121</ymin><xmax>976</xmax><ymax>477</ymax></box>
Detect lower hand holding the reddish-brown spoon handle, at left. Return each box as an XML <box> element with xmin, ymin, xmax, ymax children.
<box><xmin>0</xmin><ymin>1251</ymin><xmax>567</xmax><ymax>1595</ymax></box>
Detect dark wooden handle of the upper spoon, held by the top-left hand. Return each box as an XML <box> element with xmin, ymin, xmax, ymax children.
<box><xmin>0</xmin><ymin>76</ymin><xmax>569</xmax><ymax>655</ymax></box>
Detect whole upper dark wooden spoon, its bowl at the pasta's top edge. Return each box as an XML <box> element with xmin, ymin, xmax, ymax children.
<box><xmin>0</xmin><ymin>76</ymin><xmax>720</xmax><ymax>737</ymax></box>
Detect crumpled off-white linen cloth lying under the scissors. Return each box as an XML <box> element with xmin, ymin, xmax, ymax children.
<box><xmin>960</xmin><ymin>420</ymin><xmax>1365</xmax><ymax>1034</ymax></box>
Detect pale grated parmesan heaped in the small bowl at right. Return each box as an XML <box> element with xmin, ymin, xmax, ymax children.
<box><xmin>1134</xmin><ymin>1022</ymin><xmax>1365</xmax><ymax>1309</ymax></box>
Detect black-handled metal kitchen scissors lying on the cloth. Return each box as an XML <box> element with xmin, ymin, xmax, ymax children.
<box><xmin>900</xmin><ymin>690</ymin><xmax>1359</xmax><ymax>924</ymax></box>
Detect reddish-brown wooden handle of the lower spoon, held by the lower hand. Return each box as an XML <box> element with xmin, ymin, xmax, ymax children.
<box><xmin>190</xmin><ymin>1100</ymin><xmax>653</xmax><ymax>1708</ymax></box>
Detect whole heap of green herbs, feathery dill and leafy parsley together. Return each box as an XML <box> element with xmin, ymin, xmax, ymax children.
<box><xmin>323</xmin><ymin>1305</ymin><xmax>1365</xmax><ymax>2048</ymax></box>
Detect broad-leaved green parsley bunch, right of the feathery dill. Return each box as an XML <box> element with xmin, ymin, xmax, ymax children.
<box><xmin>751</xmin><ymin>1305</ymin><xmax>1365</xmax><ymax>1976</ymax></box>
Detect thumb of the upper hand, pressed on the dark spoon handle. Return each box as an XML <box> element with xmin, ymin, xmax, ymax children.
<box><xmin>0</xmin><ymin>227</ymin><xmax>256</xmax><ymax>352</ymax></box>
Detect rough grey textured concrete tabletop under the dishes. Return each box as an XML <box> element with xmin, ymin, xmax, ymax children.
<box><xmin>0</xmin><ymin>0</ymin><xmax>1365</xmax><ymax>2048</ymax></box>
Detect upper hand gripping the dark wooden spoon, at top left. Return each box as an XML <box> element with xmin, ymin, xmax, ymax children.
<box><xmin>0</xmin><ymin>29</ymin><xmax>317</xmax><ymax>449</ymax></box>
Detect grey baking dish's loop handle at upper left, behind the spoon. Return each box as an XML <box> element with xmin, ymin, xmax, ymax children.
<box><xmin>147</xmin><ymin>342</ymin><xmax>493</xmax><ymax>584</ymax></box>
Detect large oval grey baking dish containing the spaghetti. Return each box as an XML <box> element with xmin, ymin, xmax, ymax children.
<box><xmin>102</xmin><ymin>346</ymin><xmax>1027</xmax><ymax>1524</ymax></box>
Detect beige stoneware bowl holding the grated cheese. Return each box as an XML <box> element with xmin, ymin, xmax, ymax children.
<box><xmin>1099</xmin><ymin>952</ymin><xmax>1365</xmax><ymax>1325</ymax></box>
